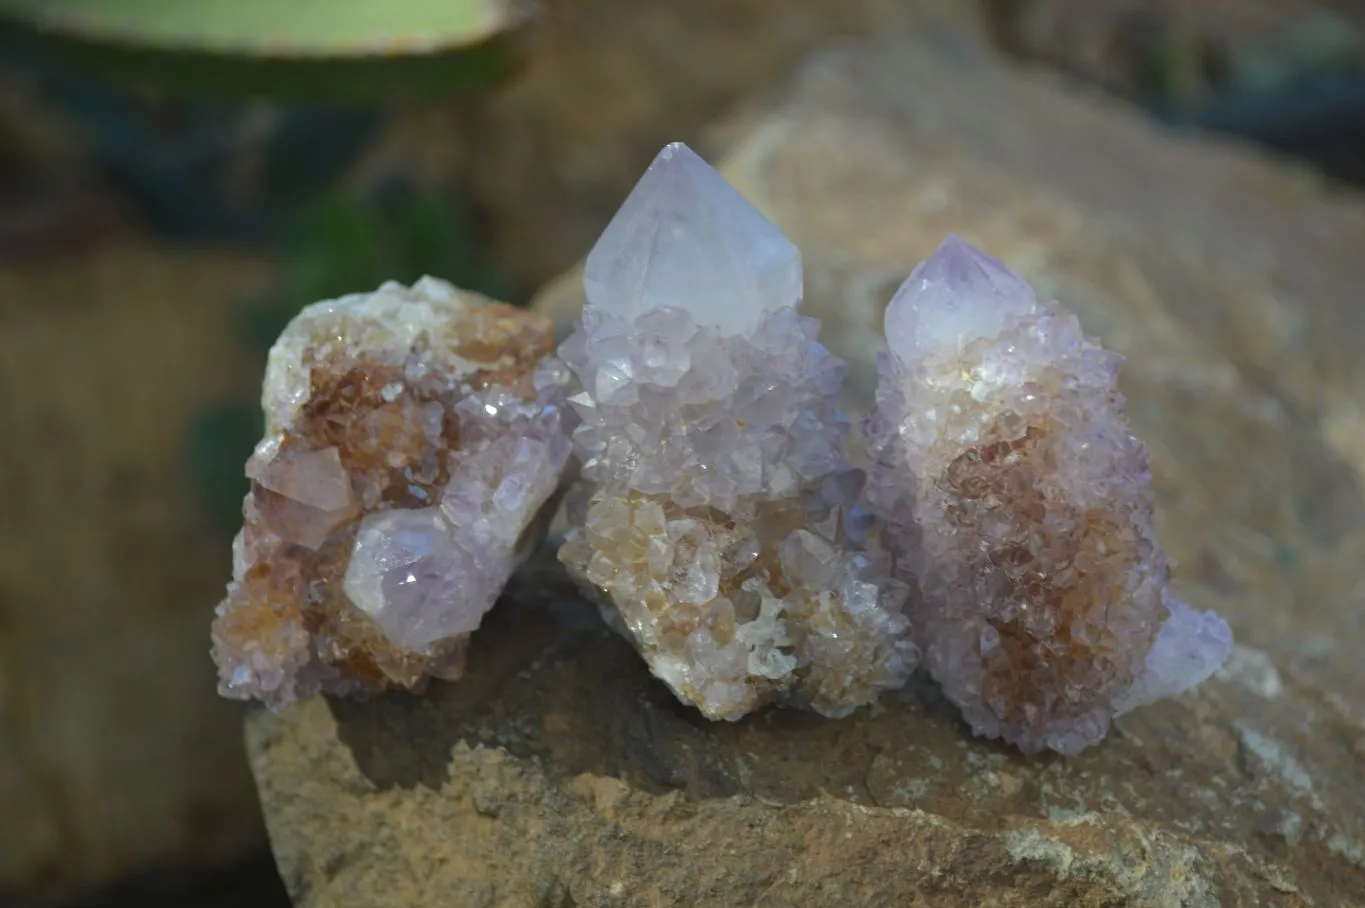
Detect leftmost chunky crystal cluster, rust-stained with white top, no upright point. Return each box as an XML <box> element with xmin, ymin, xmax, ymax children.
<box><xmin>213</xmin><ymin>277</ymin><xmax>571</xmax><ymax>709</ymax></box>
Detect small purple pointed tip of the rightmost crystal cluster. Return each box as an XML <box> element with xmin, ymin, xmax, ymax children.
<box><xmin>886</xmin><ymin>235</ymin><xmax>1036</xmax><ymax>363</ymax></box>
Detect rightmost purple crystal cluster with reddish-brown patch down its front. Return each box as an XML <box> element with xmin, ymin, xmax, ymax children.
<box><xmin>864</xmin><ymin>238</ymin><xmax>1231</xmax><ymax>754</ymax></box>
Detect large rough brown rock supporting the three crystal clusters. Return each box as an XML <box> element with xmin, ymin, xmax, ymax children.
<box><xmin>248</xmin><ymin>37</ymin><xmax>1365</xmax><ymax>907</ymax></box>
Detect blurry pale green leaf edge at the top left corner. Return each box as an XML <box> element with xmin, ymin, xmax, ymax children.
<box><xmin>0</xmin><ymin>0</ymin><xmax>520</xmax><ymax>102</ymax></box>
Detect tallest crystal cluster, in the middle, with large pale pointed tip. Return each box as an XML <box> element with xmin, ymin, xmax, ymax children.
<box><xmin>560</xmin><ymin>145</ymin><xmax>917</xmax><ymax>720</ymax></box>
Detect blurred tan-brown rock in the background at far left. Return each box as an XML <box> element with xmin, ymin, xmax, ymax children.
<box><xmin>0</xmin><ymin>243</ymin><xmax>268</xmax><ymax>904</ymax></box>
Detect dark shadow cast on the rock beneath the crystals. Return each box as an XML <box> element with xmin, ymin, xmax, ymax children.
<box><xmin>330</xmin><ymin>546</ymin><xmax>1022</xmax><ymax>804</ymax></box>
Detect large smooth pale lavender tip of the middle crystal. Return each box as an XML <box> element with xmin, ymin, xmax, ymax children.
<box><xmin>584</xmin><ymin>142</ymin><xmax>801</xmax><ymax>335</ymax></box>
